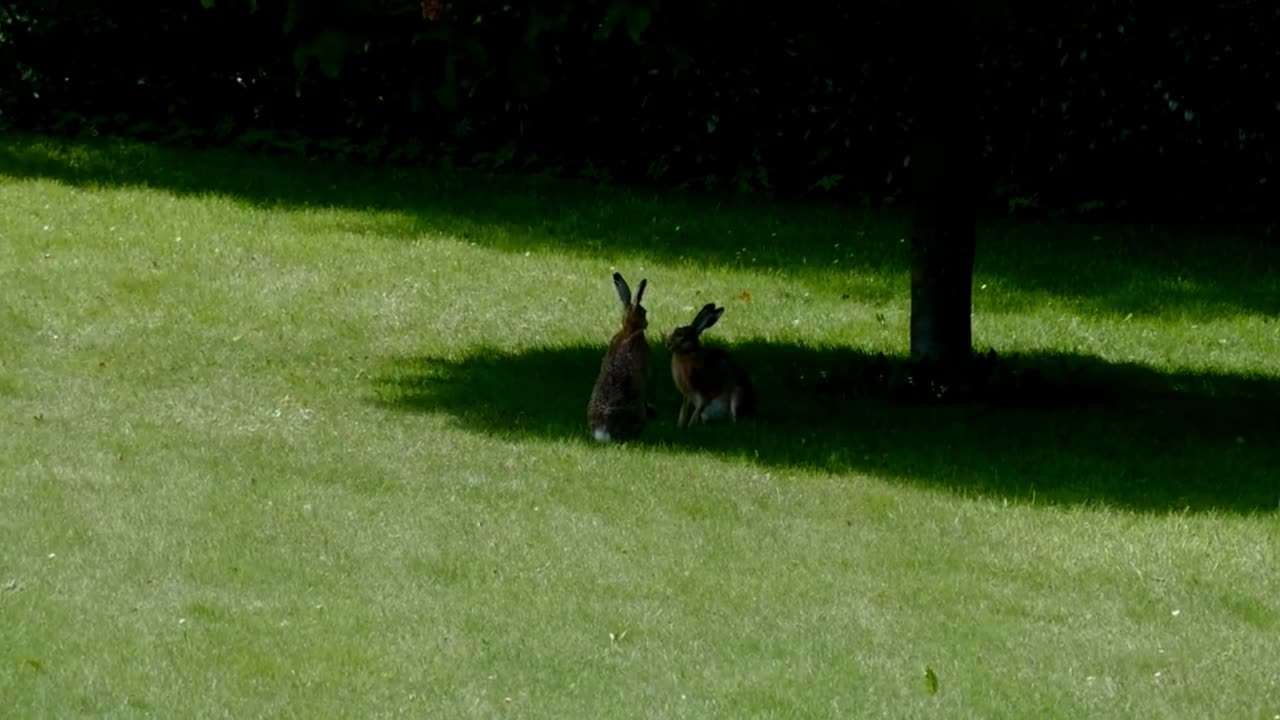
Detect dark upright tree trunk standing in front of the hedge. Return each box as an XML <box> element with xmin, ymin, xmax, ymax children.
<box><xmin>911</xmin><ymin>0</ymin><xmax>978</xmax><ymax>368</ymax></box>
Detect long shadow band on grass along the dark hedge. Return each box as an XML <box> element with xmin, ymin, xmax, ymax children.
<box><xmin>0</xmin><ymin>132</ymin><xmax>1280</xmax><ymax>316</ymax></box>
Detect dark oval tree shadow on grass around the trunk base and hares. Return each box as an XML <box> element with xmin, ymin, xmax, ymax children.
<box><xmin>374</xmin><ymin>342</ymin><xmax>1280</xmax><ymax>512</ymax></box>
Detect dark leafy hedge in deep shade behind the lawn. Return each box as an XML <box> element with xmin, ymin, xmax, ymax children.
<box><xmin>0</xmin><ymin>0</ymin><xmax>1280</xmax><ymax>213</ymax></box>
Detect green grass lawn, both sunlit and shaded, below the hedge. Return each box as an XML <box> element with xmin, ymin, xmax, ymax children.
<box><xmin>0</xmin><ymin>137</ymin><xmax>1280</xmax><ymax>720</ymax></box>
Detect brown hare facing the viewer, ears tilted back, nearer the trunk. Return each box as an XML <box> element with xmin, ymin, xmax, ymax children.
<box><xmin>667</xmin><ymin>302</ymin><xmax>755</xmax><ymax>428</ymax></box>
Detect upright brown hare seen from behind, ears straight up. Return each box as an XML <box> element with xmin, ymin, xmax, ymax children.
<box><xmin>586</xmin><ymin>273</ymin><xmax>653</xmax><ymax>442</ymax></box>
